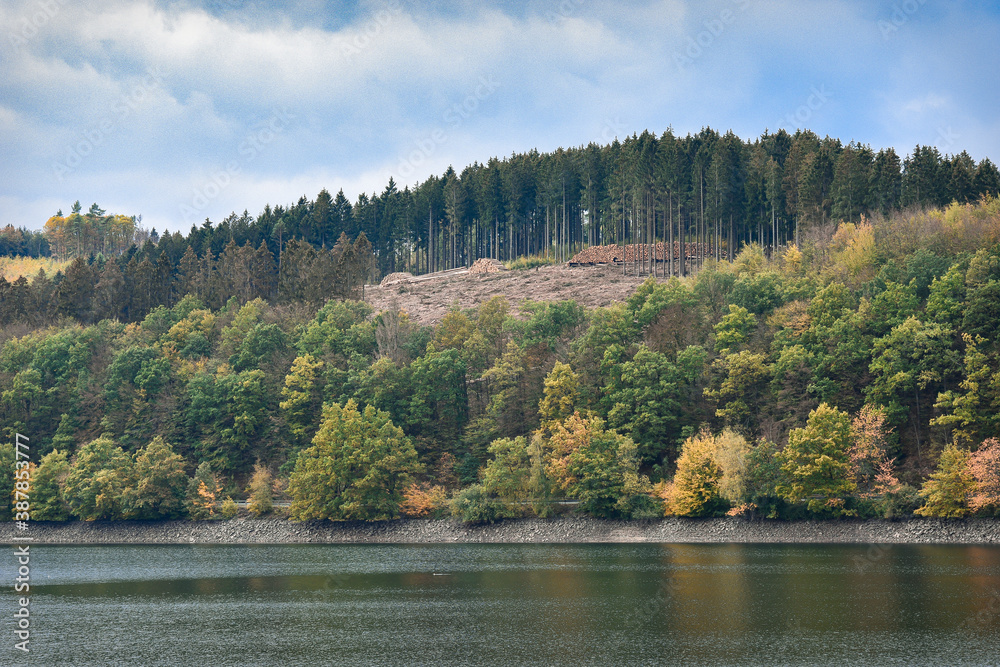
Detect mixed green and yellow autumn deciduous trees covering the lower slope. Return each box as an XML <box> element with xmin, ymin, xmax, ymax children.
<box><xmin>0</xmin><ymin>199</ymin><xmax>1000</xmax><ymax>520</ymax></box>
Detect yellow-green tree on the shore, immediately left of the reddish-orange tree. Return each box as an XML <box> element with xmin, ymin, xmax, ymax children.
<box><xmin>777</xmin><ymin>403</ymin><xmax>856</xmax><ymax>517</ymax></box>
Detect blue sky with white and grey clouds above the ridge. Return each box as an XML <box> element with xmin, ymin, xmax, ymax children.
<box><xmin>0</xmin><ymin>0</ymin><xmax>1000</xmax><ymax>232</ymax></box>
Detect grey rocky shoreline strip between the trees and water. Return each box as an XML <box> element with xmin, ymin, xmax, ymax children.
<box><xmin>0</xmin><ymin>517</ymin><xmax>1000</xmax><ymax>544</ymax></box>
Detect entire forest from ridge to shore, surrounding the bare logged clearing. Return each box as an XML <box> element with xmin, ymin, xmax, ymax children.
<box><xmin>0</xmin><ymin>125</ymin><xmax>1000</xmax><ymax>521</ymax></box>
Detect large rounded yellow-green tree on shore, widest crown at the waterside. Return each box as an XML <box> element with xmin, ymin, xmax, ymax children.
<box><xmin>289</xmin><ymin>400</ymin><xmax>420</xmax><ymax>521</ymax></box>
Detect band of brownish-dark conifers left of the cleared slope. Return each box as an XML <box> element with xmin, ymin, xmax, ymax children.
<box><xmin>0</xmin><ymin>234</ymin><xmax>373</xmax><ymax>327</ymax></box>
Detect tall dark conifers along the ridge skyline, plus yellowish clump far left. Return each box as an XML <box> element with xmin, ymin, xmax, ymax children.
<box><xmin>7</xmin><ymin>128</ymin><xmax>1000</xmax><ymax>286</ymax></box>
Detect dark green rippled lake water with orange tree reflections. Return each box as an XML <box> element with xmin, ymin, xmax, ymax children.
<box><xmin>0</xmin><ymin>545</ymin><xmax>1000</xmax><ymax>666</ymax></box>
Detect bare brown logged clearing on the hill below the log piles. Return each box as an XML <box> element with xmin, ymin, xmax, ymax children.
<box><xmin>365</xmin><ymin>265</ymin><xmax>646</xmax><ymax>325</ymax></box>
